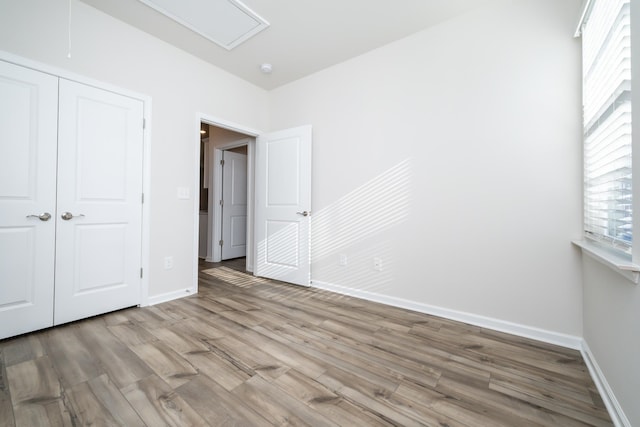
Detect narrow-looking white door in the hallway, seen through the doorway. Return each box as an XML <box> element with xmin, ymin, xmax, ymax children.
<box><xmin>221</xmin><ymin>151</ymin><xmax>247</xmax><ymax>260</ymax></box>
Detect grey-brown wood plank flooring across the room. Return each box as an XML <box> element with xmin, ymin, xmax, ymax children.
<box><xmin>0</xmin><ymin>260</ymin><xmax>612</xmax><ymax>427</ymax></box>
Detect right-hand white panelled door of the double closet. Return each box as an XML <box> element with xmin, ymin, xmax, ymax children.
<box><xmin>54</xmin><ymin>79</ymin><xmax>143</xmax><ymax>324</ymax></box>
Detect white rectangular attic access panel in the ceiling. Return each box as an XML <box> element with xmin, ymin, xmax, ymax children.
<box><xmin>139</xmin><ymin>0</ymin><xmax>269</xmax><ymax>50</ymax></box>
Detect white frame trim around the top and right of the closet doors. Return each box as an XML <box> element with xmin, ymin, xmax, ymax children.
<box><xmin>0</xmin><ymin>50</ymin><xmax>152</xmax><ymax>307</ymax></box>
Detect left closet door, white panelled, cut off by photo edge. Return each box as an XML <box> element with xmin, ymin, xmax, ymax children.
<box><xmin>0</xmin><ymin>62</ymin><xmax>58</xmax><ymax>339</ymax></box>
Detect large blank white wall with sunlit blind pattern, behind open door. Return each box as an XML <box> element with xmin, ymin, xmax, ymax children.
<box><xmin>270</xmin><ymin>0</ymin><xmax>582</xmax><ymax>336</ymax></box>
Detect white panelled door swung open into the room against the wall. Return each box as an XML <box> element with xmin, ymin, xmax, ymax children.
<box><xmin>255</xmin><ymin>126</ymin><xmax>311</xmax><ymax>286</ymax></box>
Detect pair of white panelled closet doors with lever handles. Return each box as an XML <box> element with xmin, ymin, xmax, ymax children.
<box><xmin>0</xmin><ymin>62</ymin><xmax>143</xmax><ymax>339</ymax></box>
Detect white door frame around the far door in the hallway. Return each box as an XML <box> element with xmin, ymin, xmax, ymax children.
<box><xmin>207</xmin><ymin>137</ymin><xmax>255</xmax><ymax>264</ymax></box>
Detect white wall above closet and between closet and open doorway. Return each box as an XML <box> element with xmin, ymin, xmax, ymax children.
<box><xmin>0</xmin><ymin>0</ymin><xmax>267</xmax><ymax>299</ymax></box>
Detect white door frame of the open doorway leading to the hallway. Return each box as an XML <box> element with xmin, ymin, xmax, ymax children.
<box><xmin>192</xmin><ymin>112</ymin><xmax>262</xmax><ymax>292</ymax></box>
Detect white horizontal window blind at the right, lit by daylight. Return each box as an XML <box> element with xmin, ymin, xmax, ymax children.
<box><xmin>582</xmin><ymin>0</ymin><xmax>633</xmax><ymax>254</ymax></box>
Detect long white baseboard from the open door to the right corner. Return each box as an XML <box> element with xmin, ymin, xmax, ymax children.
<box><xmin>311</xmin><ymin>280</ymin><xmax>583</xmax><ymax>350</ymax></box>
